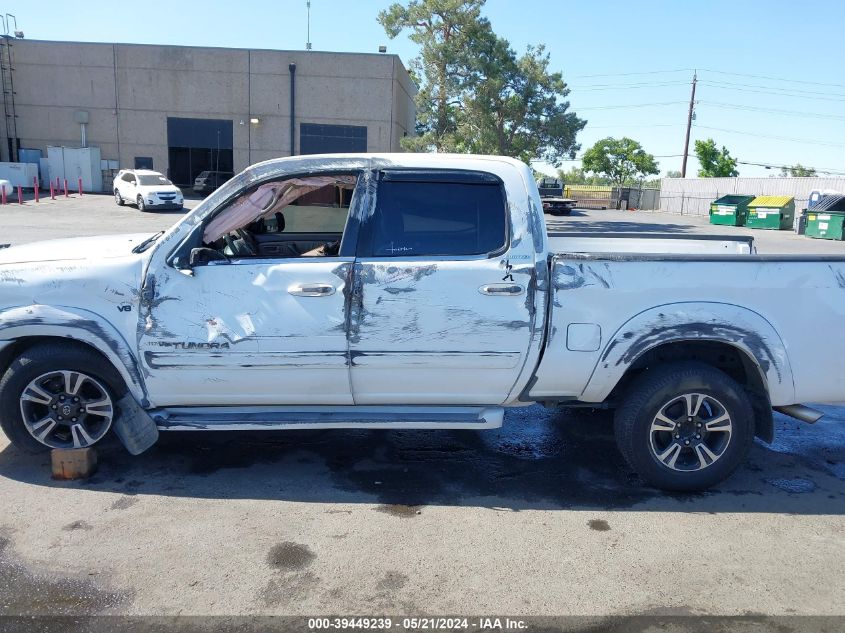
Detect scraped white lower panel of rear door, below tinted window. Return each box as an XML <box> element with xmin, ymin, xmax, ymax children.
<box><xmin>349</xmin><ymin>258</ymin><xmax>531</xmax><ymax>404</ymax></box>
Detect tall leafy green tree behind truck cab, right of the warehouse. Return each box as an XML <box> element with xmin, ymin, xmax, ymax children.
<box><xmin>378</xmin><ymin>0</ymin><xmax>586</xmax><ymax>166</ymax></box>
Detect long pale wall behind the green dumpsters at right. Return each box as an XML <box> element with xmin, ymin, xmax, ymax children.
<box><xmin>660</xmin><ymin>178</ymin><xmax>845</xmax><ymax>215</ymax></box>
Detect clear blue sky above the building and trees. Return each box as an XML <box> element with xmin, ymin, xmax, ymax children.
<box><xmin>11</xmin><ymin>0</ymin><xmax>845</xmax><ymax>176</ymax></box>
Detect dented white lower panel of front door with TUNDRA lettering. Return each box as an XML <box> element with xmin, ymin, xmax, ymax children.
<box><xmin>139</xmin><ymin>258</ymin><xmax>352</xmax><ymax>406</ymax></box>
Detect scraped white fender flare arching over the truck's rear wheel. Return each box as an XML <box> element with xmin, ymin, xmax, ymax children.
<box><xmin>581</xmin><ymin>302</ymin><xmax>795</xmax><ymax>405</ymax></box>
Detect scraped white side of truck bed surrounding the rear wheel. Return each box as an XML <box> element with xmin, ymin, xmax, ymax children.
<box><xmin>530</xmin><ymin>249</ymin><xmax>845</xmax><ymax>405</ymax></box>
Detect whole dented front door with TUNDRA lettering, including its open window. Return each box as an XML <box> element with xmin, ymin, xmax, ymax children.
<box><xmin>139</xmin><ymin>169</ymin><xmax>355</xmax><ymax>406</ymax></box>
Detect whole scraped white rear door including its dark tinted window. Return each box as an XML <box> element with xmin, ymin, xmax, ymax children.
<box><xmin>349</xmin><ymin>170</ymin><xmax>532</xmax><ymax>405</ymax></box>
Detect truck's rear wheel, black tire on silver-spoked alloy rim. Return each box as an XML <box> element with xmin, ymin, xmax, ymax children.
<box><xmin>614</xmin><ymin>362</ymin><xmax>754</xmax><ymax>492</ymax></box>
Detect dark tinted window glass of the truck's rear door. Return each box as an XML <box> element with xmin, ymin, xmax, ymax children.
<box><xmin>364</xmin><ymin>171</ymin><xmax>508</xmax><ymax>257</ymax></box>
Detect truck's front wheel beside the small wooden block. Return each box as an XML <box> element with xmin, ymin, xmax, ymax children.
<box><xmin>0</xmin><ymin>343</ymin><xmax>126</xmax><ymax>453</ymax></box>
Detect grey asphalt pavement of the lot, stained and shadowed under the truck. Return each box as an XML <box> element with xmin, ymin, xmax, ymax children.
<box><xmin>0</xmin><ymin>196</ymin><xmax>845</xmax><ymax>618</ymax></box>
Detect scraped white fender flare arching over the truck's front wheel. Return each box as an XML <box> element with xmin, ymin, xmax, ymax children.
<box><xmin>0</xmin><ymin>304</ymin><xmax>149</xmax><ymax>407</ymax></box>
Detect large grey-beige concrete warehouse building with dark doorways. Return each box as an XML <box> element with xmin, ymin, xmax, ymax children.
<box><xmin>0</xmin><ymin>40</ymin><xmax>416</xmax><ymax>186</ymax></box>
